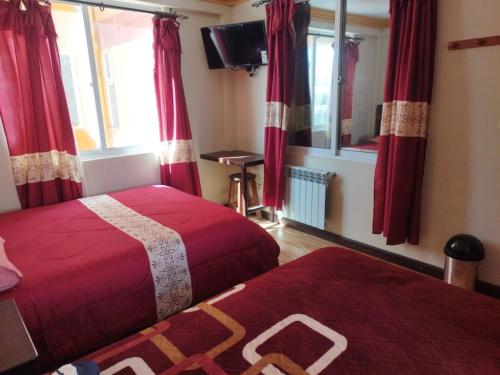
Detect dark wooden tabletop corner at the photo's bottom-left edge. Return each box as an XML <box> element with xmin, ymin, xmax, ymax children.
<box><xmin>0</xmin><ymin>299</ymin><xmax>38</xmax><ymax>373</ymax></box>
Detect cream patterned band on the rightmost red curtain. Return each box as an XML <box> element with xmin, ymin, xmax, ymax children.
<box><xmin>380</xmin><ymin>100</ymin><xmax>429</xmax><ymax>138</ymax></box>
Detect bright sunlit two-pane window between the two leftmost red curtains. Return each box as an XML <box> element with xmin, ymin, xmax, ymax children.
<box><xmin>52</xmin><ymin>3</ymin><xmax>158</xmax><ymax>155</ymax></box>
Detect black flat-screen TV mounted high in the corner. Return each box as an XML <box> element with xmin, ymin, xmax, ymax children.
<box><xmin>201</xmin><ymin>21</ymin><xmax>267</xmax><ymax>69</ymax></box>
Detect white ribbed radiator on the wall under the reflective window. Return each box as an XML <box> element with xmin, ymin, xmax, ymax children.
<box><xmin>283</xmin><ymin>165</ymin><xmax>334</xmax><ymax>229</ymax></box>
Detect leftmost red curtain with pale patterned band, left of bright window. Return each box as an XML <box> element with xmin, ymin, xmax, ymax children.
<box><xmin>0</xmin><ymin>0</ymin><xmax>82</xmax><ymax>208</ymax></box>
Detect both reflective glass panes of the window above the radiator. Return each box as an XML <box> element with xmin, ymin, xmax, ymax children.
<box><xmin>288</xmin><ymin>0</ymin><xmax>390</xmax><ymax>152</ymax></box>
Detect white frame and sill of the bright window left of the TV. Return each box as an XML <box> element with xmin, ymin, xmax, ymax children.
<box><xmin>53</xmin><ymin>0</ymin><xmax>165</xmax><ymax>161</ymax></box>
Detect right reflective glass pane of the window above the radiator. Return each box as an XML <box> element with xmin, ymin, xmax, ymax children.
<box><xmin>339</xmin><ymin>0</ymin><xmax>389</xmax><ymax>152</ymax></box>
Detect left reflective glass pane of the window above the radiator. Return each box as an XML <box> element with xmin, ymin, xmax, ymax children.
<box><xmin>287</xmin><ymin>0</ymin><xmax>336</xmax><ymax>149</ymax></box>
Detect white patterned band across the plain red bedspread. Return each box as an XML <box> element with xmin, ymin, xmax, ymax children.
<box><xmin>80</xmin><ymin>195</ymin><xmax>192</xmax><ymax>321</ymax></box>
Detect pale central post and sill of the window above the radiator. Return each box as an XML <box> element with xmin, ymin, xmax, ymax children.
<box><xmin>287</xmin><ymin>0</ymin><xmax>377</xmax><ymax>164</ymax></box>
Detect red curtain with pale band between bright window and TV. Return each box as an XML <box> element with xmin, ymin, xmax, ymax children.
<box><xmin>153</xmin><ymin>17</ymin><xmax>201</xmax><ymax>196</ymax></box>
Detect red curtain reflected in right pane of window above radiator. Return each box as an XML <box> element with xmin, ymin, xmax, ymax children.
<box><xmin>340</xmin><ymin>38</ymin><xmax>359</xmax><ymax>147</ymax></box>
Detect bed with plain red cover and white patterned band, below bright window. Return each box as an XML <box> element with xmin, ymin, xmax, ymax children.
<box><xmin>0</xmin><ymin>186</ymin><xmax>279</xmax><ymax>366</ymax></box>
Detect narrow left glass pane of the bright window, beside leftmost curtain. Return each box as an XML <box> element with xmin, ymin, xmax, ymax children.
<box><xmin>52</xmin><ymin>3</ymin><xmax>99</xmax><ymax>151</ymax></box>
